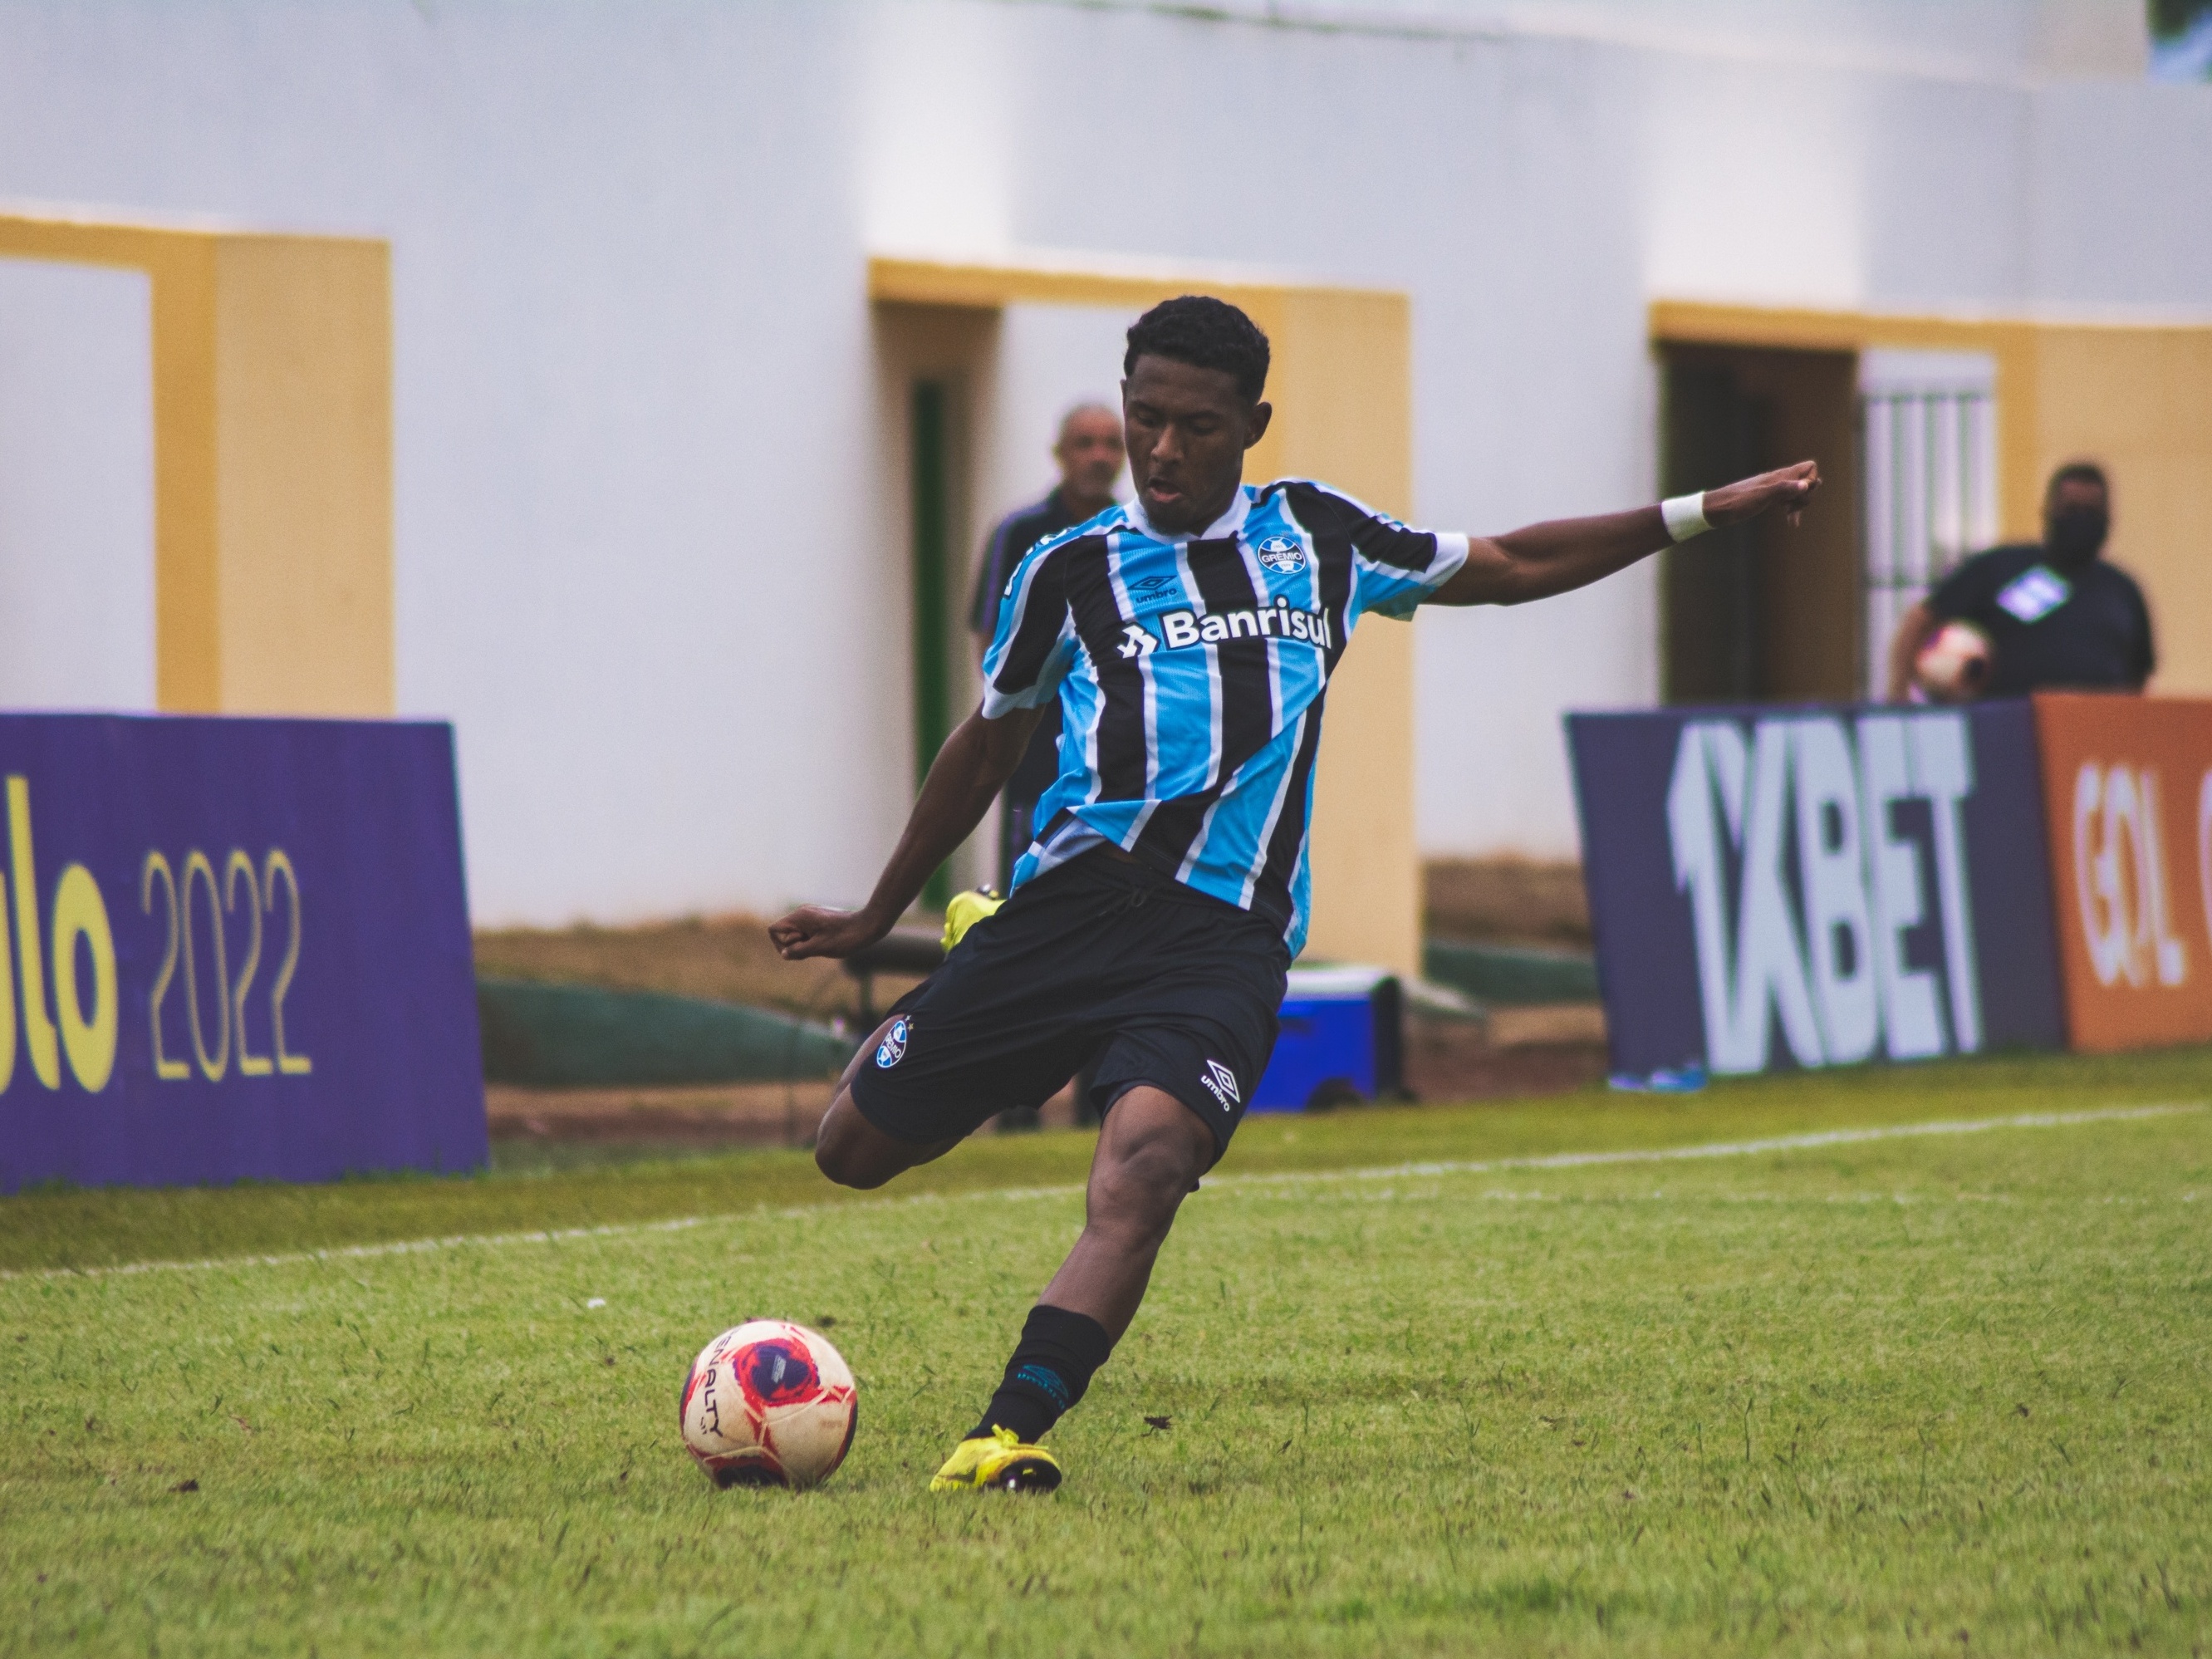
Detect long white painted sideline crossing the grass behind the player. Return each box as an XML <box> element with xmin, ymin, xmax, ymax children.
<box><xmin>0</xmin><ymin>1102</ymin><xmax>2212</xmax><ymax>1283</ymax></box>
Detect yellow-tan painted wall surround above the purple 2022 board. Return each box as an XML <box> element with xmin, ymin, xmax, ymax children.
<box><xmin>0</xmin><ymin>214</ymin><xmax>394</xmax><ymax>714</ymax></box>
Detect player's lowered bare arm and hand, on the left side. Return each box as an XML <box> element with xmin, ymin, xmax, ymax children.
<box><xmin>768</xmin><ymin>708</ymin><xmax>1044</xmax><ymax>962</ymax></box>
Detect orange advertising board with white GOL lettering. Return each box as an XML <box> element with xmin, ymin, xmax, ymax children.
<box><xmin>2024</xmin><ymin>692</ymin><xmax>2212</xmax><ymax>1053</ymax></box>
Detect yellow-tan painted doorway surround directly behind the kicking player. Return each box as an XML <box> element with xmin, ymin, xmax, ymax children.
<box><xmin>867</xmin><ymin>259</ymin><xmax>1420</xmax><ymax>974</ymax></box>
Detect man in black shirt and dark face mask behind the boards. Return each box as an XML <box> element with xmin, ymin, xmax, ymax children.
<box><xmin>1889</xmin><ymin>460</ymin><xmax>2156</xmax><ymax>704</ymax></box>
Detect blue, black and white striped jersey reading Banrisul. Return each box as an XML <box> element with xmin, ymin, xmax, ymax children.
<box><xmin>982</xmin><ymin>478</ymin><xmax>1467</xmax><ymax>954</ymax></box>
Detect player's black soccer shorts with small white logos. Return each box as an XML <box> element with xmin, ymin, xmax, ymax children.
<box><xmin>851</xmin><ymin>849</ymin><xmax>1290</xmax><ymax>1157</ymax></box>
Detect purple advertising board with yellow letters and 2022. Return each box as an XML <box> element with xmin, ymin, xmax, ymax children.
<box><xmin>0</xmin><ymin>714</ymin><xmax>487</xmax><ymax>1192</ymax></box>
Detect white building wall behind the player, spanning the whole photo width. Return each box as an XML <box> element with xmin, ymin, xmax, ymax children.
<box><xmin>0</xmin><ymin>0</ymin><xmax>2212</xmax><ymax>920</ymax></box>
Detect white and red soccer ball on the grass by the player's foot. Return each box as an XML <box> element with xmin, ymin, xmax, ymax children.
<box><xmin>679</xmin><ymin>1318</ymin><xmax>861</xmax><ymax>1486</ymax></box>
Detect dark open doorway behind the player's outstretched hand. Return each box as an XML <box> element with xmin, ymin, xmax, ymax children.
<box><xmin>1659</xmin><ymin>343</ymin><xmax>1865</xmax><ymax>704</ymax></box>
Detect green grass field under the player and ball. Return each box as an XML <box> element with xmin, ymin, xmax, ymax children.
<box><xmin>0</xmin><ymin>1051</ymin><xmax>2212</xmax><ymax>1655</ymax></box>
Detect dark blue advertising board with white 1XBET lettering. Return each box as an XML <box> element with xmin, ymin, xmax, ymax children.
<box><xmin>1568</xmin><ymin>704</ymin><xmax>2064</xmax><ymax>1075</ymax></box>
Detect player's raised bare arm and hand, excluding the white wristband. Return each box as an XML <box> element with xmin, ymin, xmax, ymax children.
<box><xmin>1429</xmin><ymin>460</ymin><xmax>1821</xmax><ymax>604</ymax></box>
